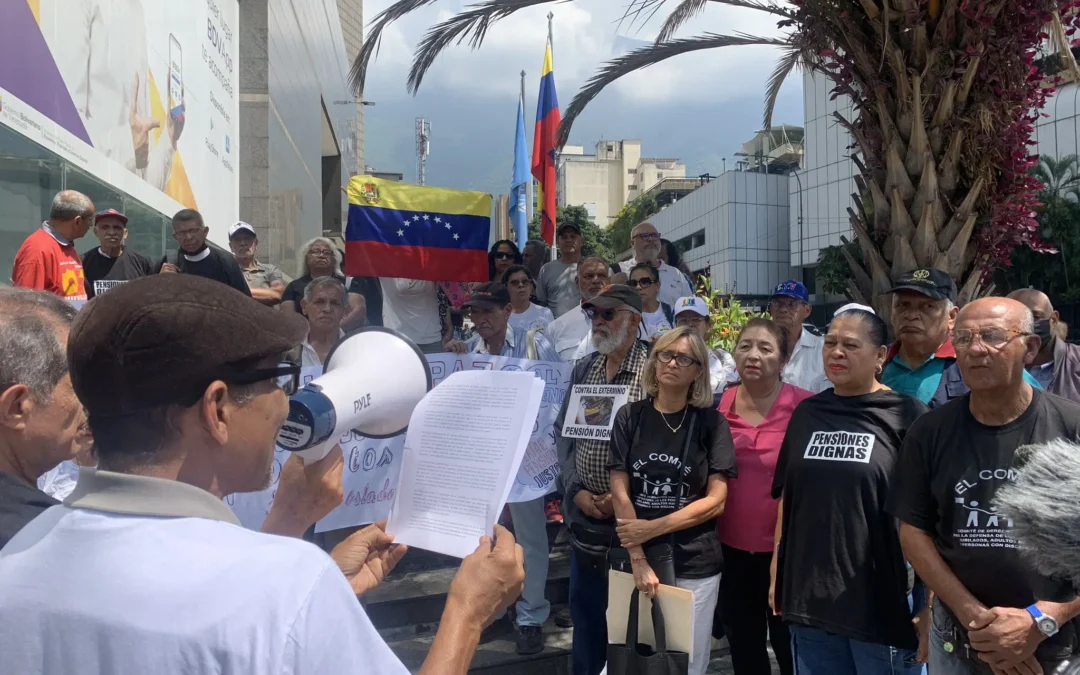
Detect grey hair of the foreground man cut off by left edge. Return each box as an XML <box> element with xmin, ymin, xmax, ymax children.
<box><xmin>0</xmin><ymin>287</ymin><xmax>76</xmax><ymax>404</ymax></box>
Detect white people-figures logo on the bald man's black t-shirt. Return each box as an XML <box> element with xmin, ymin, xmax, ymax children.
<box><xmin>953</xmin><ymin>468</ymin><xmax>1018</xmax><ymax>549</ymax></box>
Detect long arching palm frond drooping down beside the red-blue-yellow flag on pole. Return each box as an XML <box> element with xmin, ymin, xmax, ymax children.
<box><xmin>556</xmin><ymin>32</ymin><xmax>791</xmax><ymax>147</ymax></box>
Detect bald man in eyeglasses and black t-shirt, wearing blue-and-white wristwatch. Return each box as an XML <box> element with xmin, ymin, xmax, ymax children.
<box><xmin>888</xmin><ymin>298</ymin><xmax>1080</xmax><ymax>675</ymax></box>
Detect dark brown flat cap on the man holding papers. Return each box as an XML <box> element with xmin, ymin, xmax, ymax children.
<box><xmin>68</xmin><ymin>274</ymin><xmax>308</xmax><ymax>417</ymax></box>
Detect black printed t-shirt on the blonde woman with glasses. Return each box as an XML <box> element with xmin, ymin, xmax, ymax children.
<box><xmin>608</xmin><ymin>399</ymin><xmax>737</xmax><ymax>579</ymax></box>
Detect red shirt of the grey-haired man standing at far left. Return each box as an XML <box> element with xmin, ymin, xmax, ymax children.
<box><xmin>11</xmin><ymin>227</ymin><xmax>86</xmax><ymax>300</ymax></box>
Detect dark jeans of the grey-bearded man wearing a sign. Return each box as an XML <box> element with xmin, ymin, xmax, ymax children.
<box><xmin>570</xmin><ymin>550</ymin><xmax>607</xmax><ymax>675</ymax></box>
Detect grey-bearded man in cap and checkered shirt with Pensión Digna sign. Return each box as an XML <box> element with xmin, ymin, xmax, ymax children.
<box><xmin>555</xmin><ymin>285</ymin><xmax>649</xmax><ymax>675</ymax></box>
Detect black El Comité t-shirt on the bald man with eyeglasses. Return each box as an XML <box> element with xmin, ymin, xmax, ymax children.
<box><xmin>889</xmin><ymin>391</ymin><xmax>1080</xmax><ymax>607</ymax></box>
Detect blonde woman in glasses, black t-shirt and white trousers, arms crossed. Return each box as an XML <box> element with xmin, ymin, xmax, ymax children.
<box><xmin>609</xmin><ymin>328</ymin><xmax>735</xmax><ymax>675</ymax></box>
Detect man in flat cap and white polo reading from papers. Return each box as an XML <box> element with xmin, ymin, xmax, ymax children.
<box><xmin>0</xmin><ymin>274</ymin><xmax>524</xmax><ymax>675</ymax></box>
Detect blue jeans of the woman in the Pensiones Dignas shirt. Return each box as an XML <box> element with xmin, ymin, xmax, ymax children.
<box><xmin>791</xmin><ymin>625</ymin><xmax>924</xmax><ymax>675</ymax></box>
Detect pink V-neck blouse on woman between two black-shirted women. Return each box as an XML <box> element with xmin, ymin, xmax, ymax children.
<box><xmin>717</xmin><ymin>383</ymin><xmax>813</xmax><ymax>553</ymax></box>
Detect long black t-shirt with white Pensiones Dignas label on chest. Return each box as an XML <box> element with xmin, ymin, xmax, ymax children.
<box><xmin>772</xmin><ymin>389</ymin><xmax>928</xmax><ymax>649</ymax></box>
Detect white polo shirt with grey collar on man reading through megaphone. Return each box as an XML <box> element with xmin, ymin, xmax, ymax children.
<box><xmin>0</xmin><ymin>469</ymin><xmax>408</xmax><ymax>675</ymax></box>
